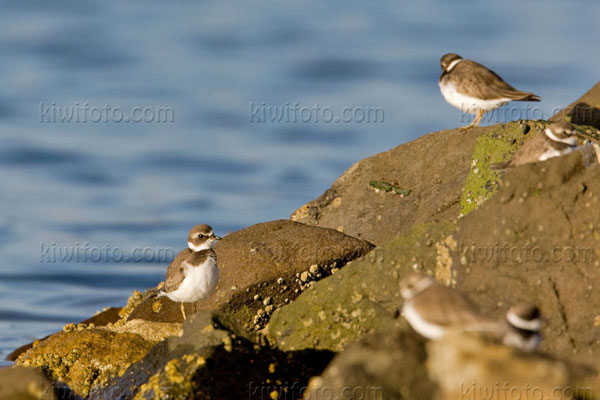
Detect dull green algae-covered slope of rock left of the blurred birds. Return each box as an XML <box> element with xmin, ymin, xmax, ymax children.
<box><xmin>267</xmin><ymin>222</ymin><xmax>454</xmax><ymax>351</ymax></box>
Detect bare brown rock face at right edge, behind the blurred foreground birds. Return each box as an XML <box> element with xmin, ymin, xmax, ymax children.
<box><xmin>450</xmin><ymin>149</ymin><xmax>600</xmax><ymax>363</ymax></box>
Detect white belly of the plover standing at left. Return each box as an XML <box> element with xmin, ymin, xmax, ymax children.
<box><xmin>166</xmin><ymin>258</ymin><xmax>219</xmax><ymax>303</ymax></box>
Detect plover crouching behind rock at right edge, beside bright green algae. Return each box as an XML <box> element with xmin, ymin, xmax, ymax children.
<box><xmin>491</xmin><ymin>121</ymin><xmax>583</xmax><ymax>170</ymax></box>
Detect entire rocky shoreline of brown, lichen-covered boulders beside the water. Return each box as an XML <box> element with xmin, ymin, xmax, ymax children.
<box><xmin>0</xmin><ymin>83</ymin><xmax>600</xmax><ymax>399</ymax></box>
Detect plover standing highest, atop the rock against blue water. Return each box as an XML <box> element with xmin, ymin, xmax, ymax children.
<box><xmin>439</xmin><ymin>53</ymin><xmax>540</xmax><ymax>128</ymax></box>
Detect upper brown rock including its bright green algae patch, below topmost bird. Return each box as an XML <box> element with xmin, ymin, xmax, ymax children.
<box><xmin>290</xmin><ymin>111</ymin><xmax>600</xmax><ymax>245</ymax></box>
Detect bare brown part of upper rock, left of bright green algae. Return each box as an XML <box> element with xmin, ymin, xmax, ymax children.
<box><xmin>291</xmin><ymin>123</ymin><xmax>512</xmax><ymax>246</ymax></box>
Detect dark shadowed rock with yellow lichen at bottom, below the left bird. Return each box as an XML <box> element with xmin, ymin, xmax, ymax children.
<box><xmin>89</xmin><ymin>312</ymin><xmax>332</xmax><ymax>400</ymax></box>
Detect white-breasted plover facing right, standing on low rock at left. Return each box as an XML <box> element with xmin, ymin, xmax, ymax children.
<box><xmin>159</xmin><ymin>224</ymin><xmax>221</xmax><ymax>319</ymax></box>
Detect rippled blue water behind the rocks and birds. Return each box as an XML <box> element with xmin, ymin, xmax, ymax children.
<box><xmin>0</xmin><ymin>0</ymin><xmax>600</xmax><ymax>357</ymax></box>
